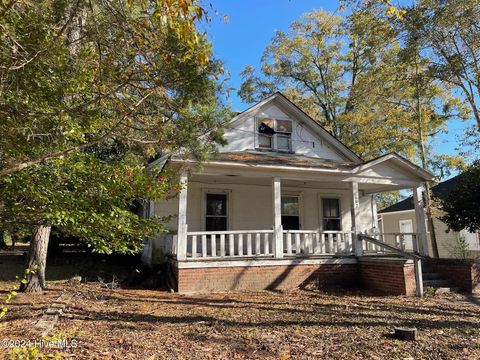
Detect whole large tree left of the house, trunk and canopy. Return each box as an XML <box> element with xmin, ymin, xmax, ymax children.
<box><xmin>0</xmin><ymin>0</ymin><xmax>228</xmax><ymax>291</ymax></box>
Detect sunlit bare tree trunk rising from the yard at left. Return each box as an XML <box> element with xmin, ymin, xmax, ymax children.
<box><xmin>20</xmin><ymin>225</ymin><xmax>51</xmax><ymax>292</ymax></box>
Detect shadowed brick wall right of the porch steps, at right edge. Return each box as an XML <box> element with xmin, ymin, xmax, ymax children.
<box><xmin>426</xmin><ymin>259</ymin><xmax>480</xmax><ymax>293</ymax></box>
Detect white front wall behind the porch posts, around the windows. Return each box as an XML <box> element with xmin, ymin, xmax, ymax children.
<box><xmin>155</xmin><ymin>182</ymin><xmax>372</xmax><ymax>232</ymax></box>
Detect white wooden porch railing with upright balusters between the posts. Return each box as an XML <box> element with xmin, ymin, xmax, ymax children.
<box><xmin>174</xmin><ymin>230</ymin><xmax>418</xmax><ymax>260</ymax></box>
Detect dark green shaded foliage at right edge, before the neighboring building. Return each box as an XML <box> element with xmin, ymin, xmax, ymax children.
<box><xmin>440</xmin><ymin>161</ymin><xmax>480</xmax><ymax>232</ymax></box>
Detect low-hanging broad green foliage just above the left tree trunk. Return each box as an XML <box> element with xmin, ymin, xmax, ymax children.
<box><xmin>0</xmin><ymin>153</ymin><xmax>178</xmax><ymax>253</ymax></box>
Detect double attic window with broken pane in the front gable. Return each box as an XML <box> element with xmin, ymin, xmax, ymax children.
<box><xmin>257</xmin><ymin>118</ymin><xmax>292</xmax><ymax>152</ymax></box>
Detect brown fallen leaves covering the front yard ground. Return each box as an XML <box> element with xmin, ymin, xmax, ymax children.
<box><xmin>0</xmin><ymin>253</ymin><xmax>480</xmax><ymax>359</ymax></box>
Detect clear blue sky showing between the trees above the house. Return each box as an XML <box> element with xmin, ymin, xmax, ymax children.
<box><xmin>202</xmin><ymin>0</ymin><xmax>473</xmax><ymax>160</ymax></box>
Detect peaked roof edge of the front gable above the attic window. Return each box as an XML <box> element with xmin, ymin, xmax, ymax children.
<box><xmin>230</xmin><ymin>91</ymin><xmax>363</xmax><ymax>164</ymax></box>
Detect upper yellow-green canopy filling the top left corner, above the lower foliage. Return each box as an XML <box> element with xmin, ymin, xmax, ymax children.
<box><xmin>0</xmin><ymin>0</ymin><xmax>222</xmax><ymax>176</ymax></box>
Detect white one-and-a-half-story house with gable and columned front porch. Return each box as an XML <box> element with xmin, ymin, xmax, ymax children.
<box><xmin>144</xmin><ymin>93</ymin><xmax>432</xmax><ymax>292</ymax></box>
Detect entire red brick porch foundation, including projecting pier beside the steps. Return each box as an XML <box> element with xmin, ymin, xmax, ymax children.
<box><xmin>176</xmin><ymin>257</ymin><xmax>416</xmax><ymax>296</ymax></box>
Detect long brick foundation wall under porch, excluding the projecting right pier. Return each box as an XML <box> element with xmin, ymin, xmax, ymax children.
<box><xmin>177</xmin><ymin>260</ymin><xmax>358</xmax><ymax>293</ymax></box>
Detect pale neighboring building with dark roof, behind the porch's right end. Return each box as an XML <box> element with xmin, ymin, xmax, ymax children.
<box><xmin>378</xmin><ymin>177</ymin><xmax>480</xmax><ymax>258</ymax></box>
